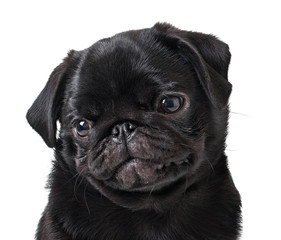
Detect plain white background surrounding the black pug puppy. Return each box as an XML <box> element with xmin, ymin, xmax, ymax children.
<box><xmin>0</xmin><ymin>0</ymin><xmax>281</xmax><ymax>240</ymax></box>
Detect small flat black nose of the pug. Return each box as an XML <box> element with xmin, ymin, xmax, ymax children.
<box><xmin>112</xmin><ymin>122</ymin><xmax>137</xmax><ymax>142</ymax></box>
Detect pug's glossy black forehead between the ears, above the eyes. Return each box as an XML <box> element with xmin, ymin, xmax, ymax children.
<box><xmin>68</xmin><ymin>35</ymin><xmax>195</xmax><ymax>108</ymax></box>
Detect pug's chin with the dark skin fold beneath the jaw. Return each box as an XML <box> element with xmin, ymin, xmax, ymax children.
<box><xmin>87</xmin><ymin>157</ymin><xmax>191</xmax><ymax>211</ymax></box>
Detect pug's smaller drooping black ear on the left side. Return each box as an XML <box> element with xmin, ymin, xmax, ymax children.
<box><xmin>26</xmin><ymin>50</ymin><xmax>76</xmax><ymax>147</ymax></box>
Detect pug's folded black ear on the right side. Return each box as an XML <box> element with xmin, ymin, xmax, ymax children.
<box><xmin>154</xmin><ymin>23</ymin><xmax>232</xmax><ymax>109</ymax></box>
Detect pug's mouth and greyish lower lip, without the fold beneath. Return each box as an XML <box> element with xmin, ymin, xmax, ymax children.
<box><xmin>88</xmin><ymin>154</ymin><xmax>192</xmax><ymax>192</ymax></box>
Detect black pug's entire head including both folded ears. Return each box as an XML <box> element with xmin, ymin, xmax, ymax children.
<box><xmin>27</xmin><ymin>24</ymin><xmax>231</xmax><ymax>209</ymax></box>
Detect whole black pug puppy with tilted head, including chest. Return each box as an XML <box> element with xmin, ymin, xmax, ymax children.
<box><xmin>27</xmin><ymin>23</ymin><xmax>240</xmax><ymax>240</ymax></box>
